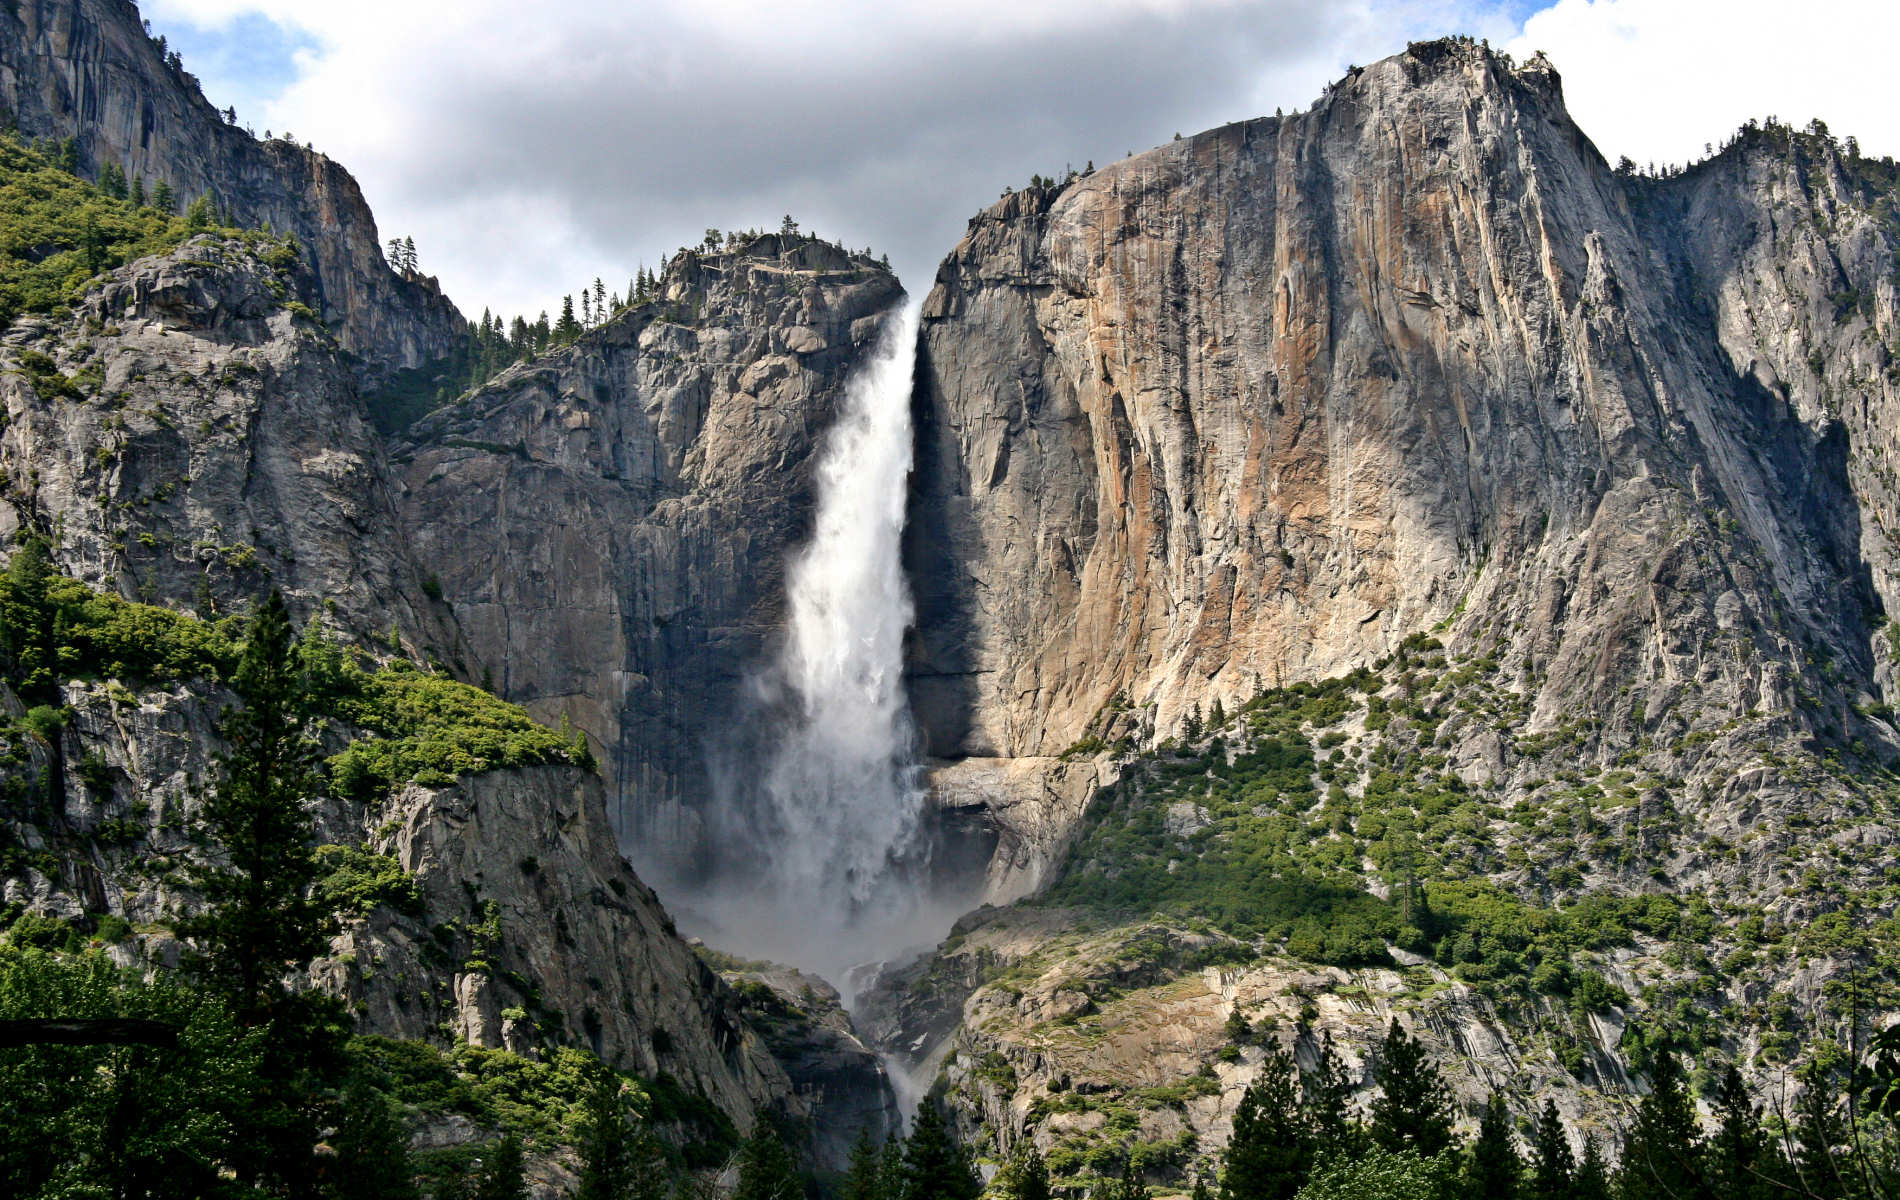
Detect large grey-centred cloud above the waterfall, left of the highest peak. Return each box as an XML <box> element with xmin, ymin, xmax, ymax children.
<box><xmin>148</xmin><ymin>0</ymin><xmax>1514</xmax><ymax>315</ymax></box>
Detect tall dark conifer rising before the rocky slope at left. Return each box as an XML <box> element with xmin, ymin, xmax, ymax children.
<box><xmin>177</xmin><ymin>591</ymin><xmax>331</xmax><ymax>1023</ymax></box>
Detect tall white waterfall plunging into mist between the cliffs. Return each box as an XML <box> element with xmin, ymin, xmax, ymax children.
<box><xmin>680</xmin><ymin>302</ymin><xmax>975</xmax><ymax>993</ymax></box>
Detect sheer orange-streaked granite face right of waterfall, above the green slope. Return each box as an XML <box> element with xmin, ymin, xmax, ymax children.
<box><xmin>908</xmin><ymin>42</ymin><xmax>1896</xmax><ymax>873</ymax></box>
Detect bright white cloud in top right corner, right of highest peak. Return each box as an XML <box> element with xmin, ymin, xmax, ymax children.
<box><xmin>1509</xmin><ymin>0</ymin><xmax>1900</xmax><ymax>163</ymax></box>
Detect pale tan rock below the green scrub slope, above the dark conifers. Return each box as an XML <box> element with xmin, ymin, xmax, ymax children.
<box><xmin>861</xmin><ymin>908</ymin><xmax>1659</xmax><ymax>1181</ymax></box>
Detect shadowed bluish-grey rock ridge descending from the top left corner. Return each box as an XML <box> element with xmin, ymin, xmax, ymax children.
<box><xmin>0</xmin><ymin>0</ymin><xmax>464</xmax><ymax>372</ymax></box>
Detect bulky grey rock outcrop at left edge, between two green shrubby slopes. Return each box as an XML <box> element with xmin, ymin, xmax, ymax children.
<box><xmin>0</xmin><ymin>235</ymin><xmax>458</xmax><ymax>659</ymax></box>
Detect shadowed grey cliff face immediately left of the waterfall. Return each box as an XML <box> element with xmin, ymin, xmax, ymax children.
<box><xmin>397</xmin><ymin>235</ymin><xmax>903</xmax><ymax>891</ymax></box>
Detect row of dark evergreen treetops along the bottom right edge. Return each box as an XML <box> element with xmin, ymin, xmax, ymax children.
<box><xmin>994</xmin><ymin>1022</ymin><xmax>1900</xmax><ymax>1200</ymax></box>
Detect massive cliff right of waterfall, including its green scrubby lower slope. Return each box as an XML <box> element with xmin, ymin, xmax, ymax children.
<box><xmin>885</xmin><ymin>40</ymin><xmax>1900</xmax><ymax>1179</ymax></box>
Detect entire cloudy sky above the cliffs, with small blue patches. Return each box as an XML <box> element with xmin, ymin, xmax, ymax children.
<box><xmin>143</xmin><ymin>0</ymin><xmax>1900</xmax><ymax>317</ymax></box>
